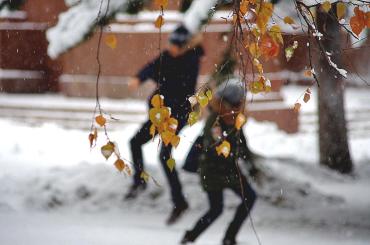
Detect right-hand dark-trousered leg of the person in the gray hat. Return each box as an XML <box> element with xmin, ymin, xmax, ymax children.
<box><xmin>224</xmin><ymin>178</ymin><xmax>257</xmax><ymax>244</ymax></box>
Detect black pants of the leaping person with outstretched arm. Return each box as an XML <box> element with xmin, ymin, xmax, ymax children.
<box><xmin>130</xmin><ymin>113</ymin><xmax>186</xmax><ymax>207</ymax></box>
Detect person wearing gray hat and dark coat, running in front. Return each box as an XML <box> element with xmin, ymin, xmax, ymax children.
<box><xmin>181</xmin><ymin>81</ymin><xmax>257</xmax><ymax>245</ymax></box>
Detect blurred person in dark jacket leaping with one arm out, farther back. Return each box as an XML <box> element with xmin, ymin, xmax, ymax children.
<box><xmin>125</xmin><ymin>26</ymin><xmax>204</xmax><ymax>224</ymax></box>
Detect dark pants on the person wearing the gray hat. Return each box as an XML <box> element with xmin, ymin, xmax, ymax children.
<box><xmin>189</xmin><ymin>180</ymin><xmax>256</xmax><ymax>240</ymax></box>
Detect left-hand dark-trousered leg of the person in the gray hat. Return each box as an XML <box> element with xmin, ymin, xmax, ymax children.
<box><xmin>181</xmin><ymin>190</ymin><xmax>223</xmax><ymax>244</ymax></box>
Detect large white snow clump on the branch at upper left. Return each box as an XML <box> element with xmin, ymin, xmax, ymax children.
<box><xmin>46</xmin><ymin>0</ymin><xmax>129</xmax><ymax>58</ymax></box>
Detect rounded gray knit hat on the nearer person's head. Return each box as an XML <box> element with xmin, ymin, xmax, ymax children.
<box><xmin>216</xmin><ymin>79</ymin><xmax>245</xmax><ymax>107</ymax></box>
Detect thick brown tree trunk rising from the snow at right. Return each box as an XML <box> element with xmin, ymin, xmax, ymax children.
<box><xmin>317</xmin><ymin>4</ymin><xmax>353</xmax><ymax>173</ymax></box>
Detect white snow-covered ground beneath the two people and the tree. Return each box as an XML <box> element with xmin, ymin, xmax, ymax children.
<box><xmin>0</xmin><ymin>86</ymin><xmax>370</xmax><ymax>245</ymax></box>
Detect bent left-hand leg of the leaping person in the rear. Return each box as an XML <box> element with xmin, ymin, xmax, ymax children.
<box><xmin>125</xmin><ymin>121</ymin><xmax>151</xmax><ymax>199</ymax></box>
